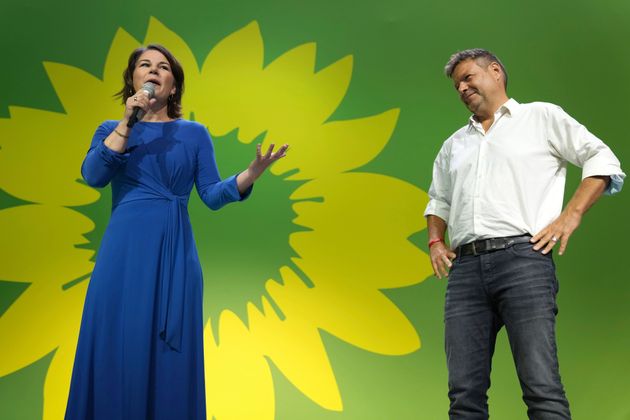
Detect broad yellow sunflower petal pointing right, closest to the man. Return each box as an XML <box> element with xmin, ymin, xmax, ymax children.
<box><xmin>289</xmin><ymin>173</ymin><xmax>432</xmax><ymax>289</ymax></box>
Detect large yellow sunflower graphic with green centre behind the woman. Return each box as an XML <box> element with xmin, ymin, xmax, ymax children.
<box><xmin>0</xmin><ymin>18</ymin><xmax>431</xmax><ymax>420</ymax></box>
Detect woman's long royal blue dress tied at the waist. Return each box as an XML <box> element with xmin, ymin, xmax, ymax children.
<box><xmin>66</xmin><ymin>120</ymin><xmax>250</xmax><ymax>420</ymax></box>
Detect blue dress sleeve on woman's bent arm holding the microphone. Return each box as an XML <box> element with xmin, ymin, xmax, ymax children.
<box><xmin>81</xmin><ymin>121</ymin><xmax>129</xmax><ymax>188</ymax></box>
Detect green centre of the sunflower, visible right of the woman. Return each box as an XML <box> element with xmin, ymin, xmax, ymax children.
<box><xmin>188</xmin><ymin>132</ymin><xmax>299</xmax><ymax>331</ymax></box>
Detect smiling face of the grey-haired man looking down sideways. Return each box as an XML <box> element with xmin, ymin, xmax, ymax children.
<box><xmin>452</xmin><ymin>59</ymin><xmax>504</xmax><ymax>114</ymax></box>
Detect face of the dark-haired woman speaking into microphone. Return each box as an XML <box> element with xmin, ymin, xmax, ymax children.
<box><xmin>133</xmin><ymin>50</ymin><xmax>176</xmax><ymax>102</ymax></box>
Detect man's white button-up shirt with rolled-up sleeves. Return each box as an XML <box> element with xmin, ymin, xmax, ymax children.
<box><xmin>424</xmin><ymin>99</ymin><xmax>625</xmax><ymax>248</ymax></box>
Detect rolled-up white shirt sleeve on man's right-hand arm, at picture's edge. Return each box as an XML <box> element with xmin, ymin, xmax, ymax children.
<box><xmin>547</xmin><ymin>105</ymin><xmax>626</xmax><ymax>194</ymax></box>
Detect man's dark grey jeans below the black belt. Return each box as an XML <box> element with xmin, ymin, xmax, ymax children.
<box><xmin>444</xmin><ymin>243</ymin><xmax>571</xmax><ymax>420</ymax></box>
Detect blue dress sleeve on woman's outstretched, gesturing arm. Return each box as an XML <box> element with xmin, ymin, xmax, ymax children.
<box><xmin>195</xmin><ymin>128</ymin><xmax>253</xmax><ymax>210</ymax></box>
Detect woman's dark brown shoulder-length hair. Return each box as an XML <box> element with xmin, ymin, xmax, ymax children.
<box><xmin>115</xmin><ymin>44</ymin><xmax>184</xmax><ymax>118</ymax></box>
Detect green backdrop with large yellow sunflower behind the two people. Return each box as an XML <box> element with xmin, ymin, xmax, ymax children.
<box><xmin>0</xmin><ymin>0</ymin><xmax>630</xmax><ymax>420</ymax></box>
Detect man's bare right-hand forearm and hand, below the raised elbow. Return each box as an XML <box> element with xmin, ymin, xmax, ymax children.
<box><xmin>532</xmin><ymin>176</ymin><xmax>610</xmax><ymax>255</ymax></box>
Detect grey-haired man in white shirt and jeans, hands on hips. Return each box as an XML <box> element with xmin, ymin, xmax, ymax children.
<box><xmin>425</xmin><ymin>49</ymin><xmax>625</xmax><ymax>420</ymax></box>
